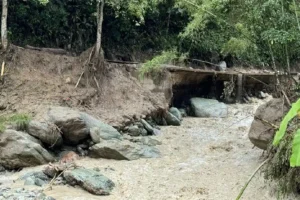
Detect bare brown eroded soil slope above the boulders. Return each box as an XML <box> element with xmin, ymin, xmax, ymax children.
<box><xmin>0</xmin><ymin>46</ymin><xmax>167</xmax><ymax>125</ymax></box>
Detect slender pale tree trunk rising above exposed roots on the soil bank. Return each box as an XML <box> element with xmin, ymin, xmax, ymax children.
<box><xmin>95</xmin><ymin>0</ymin><xmax>105</xmax><ymax>59</ymax></box>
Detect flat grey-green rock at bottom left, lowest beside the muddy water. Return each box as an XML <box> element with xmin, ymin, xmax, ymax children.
<box><xmin>63</xmin><ymin>169</ymin><xmax>115</xmax><ymax>195</ymax></box>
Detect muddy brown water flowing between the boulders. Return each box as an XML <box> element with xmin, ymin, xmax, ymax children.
<box><xmin>0</xmin><ymin>99</ymin><xmax>288</xmax><ymax>200</ymax></box>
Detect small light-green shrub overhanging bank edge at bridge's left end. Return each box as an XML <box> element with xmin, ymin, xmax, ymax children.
<box><xmin>139</xmin><ymin>50</ymin><xmax>178</xmax><ymax>79</ymax></box>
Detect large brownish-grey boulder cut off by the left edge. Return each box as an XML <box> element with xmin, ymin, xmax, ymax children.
<box><xmin>0</xmin><ymin>130</ymin><xmax>54</xmax><ymax>169</ymax></box>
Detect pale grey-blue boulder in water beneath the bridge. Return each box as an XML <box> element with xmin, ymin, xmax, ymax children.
<box><xmin>191</xmin><ymin>98</ymin><xmax>228</xmax><ymax>118</ymax></box>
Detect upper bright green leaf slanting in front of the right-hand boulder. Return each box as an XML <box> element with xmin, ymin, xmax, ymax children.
<box><xmin>273</xmin><ymin>99</ymin><xmax>300</xmax><ymax>146</ymax></box>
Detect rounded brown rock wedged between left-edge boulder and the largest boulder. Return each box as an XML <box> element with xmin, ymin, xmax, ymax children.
<box><xmin>28</xmin><ymin>121</ymin><xmax>63</xmax><ymax>146</ymax></box>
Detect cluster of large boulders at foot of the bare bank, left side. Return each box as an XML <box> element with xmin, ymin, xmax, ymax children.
<box><xmin>0</xmin><ymin>107</ymin><xmax>160</xmax><ymax>169</ymax></box>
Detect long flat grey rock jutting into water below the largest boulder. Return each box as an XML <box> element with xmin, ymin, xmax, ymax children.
<box><xmin>90</xmin><ymin>140</ymin><xmax>160</xmax><ymax>160</ymax></box>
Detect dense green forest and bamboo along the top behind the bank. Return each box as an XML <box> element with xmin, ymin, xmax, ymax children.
<box><xmin>3</xmin><ymin>0</ymin><xmax>300</xmax><ymax>69</ymax></box>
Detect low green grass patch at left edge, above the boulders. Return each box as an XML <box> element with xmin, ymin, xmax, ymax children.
<box><xmin>0</xmin><ymin>114</ymin><xmax>31</xmax><ymax>132</ymax></box>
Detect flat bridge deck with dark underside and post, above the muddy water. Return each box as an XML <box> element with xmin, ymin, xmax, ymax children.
<box><xmin>164</xmin><ymin>65</ymin><xmax>299</xmax><ymax>103</ymax></box>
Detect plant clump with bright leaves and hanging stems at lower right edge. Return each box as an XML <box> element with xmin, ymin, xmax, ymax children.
<box><xmin>265</xmin><ymin>99</ymin><xmax>300</xmax><ymax>197</ymax></box>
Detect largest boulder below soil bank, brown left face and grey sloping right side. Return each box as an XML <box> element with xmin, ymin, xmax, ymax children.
<box><xmin>47</xmin><ymin>107</ymin><xmax>121</xmax><ymax>144</ymax></box>
